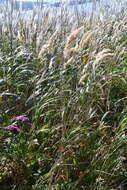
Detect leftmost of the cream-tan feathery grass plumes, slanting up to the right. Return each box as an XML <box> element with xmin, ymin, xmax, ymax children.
<box><xmin>38</xmin><ymin>31</ymin><xmax>58</xmax><ymax>58</ymax></box>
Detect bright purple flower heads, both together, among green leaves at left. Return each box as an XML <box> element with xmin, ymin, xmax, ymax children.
<box><xmin>4</xmin><ymin>116</ymin><xmax>32</xmax><ymax>135</ymax></box>
